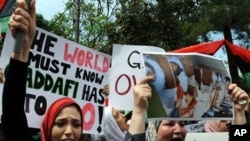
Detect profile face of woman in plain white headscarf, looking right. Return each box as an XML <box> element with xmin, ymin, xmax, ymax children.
<box><xmin>112</xmin><ymin>108</ymin><xmax>129</xmax><ymax>132</ymax></box>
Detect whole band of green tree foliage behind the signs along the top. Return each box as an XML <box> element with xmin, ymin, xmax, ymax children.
<box><xmin>39</xmin><ymin>0</ymin><xmax>250</xmax><ymax>60</ymax></box>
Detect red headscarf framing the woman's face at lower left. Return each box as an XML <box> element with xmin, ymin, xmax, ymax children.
<box><xmin>41</xmin><ymin>97</ymin><xmax>83</xmax><ymax>141</ymax></box>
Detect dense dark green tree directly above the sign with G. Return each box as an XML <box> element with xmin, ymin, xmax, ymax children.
<box><xmin>108</xmin><ymin>0</ymin><xmax>190</xmax><ymax>50</ymax></box>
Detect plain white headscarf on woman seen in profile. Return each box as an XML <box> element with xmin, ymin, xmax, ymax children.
<box><xmin>102</xmin><ymin>107</ymin><xmax>126</xmax><ymax>141</ymax></box>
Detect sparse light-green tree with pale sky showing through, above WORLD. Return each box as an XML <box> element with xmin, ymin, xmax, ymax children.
<box><xmin>47</xmin><ymin>0</ymin><xmax>116</xmax><ymax>53</ymax></box>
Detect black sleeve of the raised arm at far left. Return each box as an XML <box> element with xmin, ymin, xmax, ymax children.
<box><xmin>1</xmin><ymin>59</ymin><xmax>34</xmax><ymax>141</ymax></box>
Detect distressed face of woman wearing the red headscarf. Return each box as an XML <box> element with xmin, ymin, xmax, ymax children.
<box><xmin>51</xmin><ymin>106</ymin><xmax>82</xmax><ymax>141</ymax></box>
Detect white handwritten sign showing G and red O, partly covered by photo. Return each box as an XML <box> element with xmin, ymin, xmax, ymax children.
<box><xmin>109</xmin><ymin>44</ymin><xmax>165</xmax><ymax>110</ymax></box>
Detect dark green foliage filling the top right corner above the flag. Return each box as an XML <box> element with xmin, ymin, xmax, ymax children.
<box><xmin>193</xmin><ymin>0</ymin><xmax>250</xmax><ymax>39</ymax></box>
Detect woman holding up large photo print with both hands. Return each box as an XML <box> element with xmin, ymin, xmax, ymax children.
<box><xmin>125</xmin><ymin>76</ymin><xmax>249</xmax><ymax>141</ymax></box>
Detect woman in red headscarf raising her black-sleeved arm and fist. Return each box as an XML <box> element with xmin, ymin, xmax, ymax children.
<box><xmin>1</xmin><ymin>0</ymin><xmax>83</xmax><ymax>141</ymax></box>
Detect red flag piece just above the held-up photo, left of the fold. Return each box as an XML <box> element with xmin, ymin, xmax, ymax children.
<box><xmin>171</xmin><ymin>40</ymin><xmax>225</xmax><ymax>55</ymax></box>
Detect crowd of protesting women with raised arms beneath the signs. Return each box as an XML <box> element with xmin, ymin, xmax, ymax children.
<box><xmin>1</xmin><ymin>0</ymin><xmax>249</xmax><ymax>141</ymax></box>
